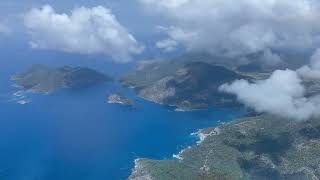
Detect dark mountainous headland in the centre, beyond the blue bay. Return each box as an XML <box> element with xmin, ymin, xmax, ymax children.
<box><xmin>121</xmin><ymin>52</ymin><xmax>269</xmax><ymax>111</ymax></box>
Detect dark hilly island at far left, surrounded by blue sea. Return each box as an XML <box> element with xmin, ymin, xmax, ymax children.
<box><xmin>13</xmin><ymin>65</ymin><xmax>111</xmax><ymax>93</ymax></box>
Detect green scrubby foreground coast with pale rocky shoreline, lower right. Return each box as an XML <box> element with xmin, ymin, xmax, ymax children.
<box><xmin>129</xmin><ymin>115</ymin><xmax>320</xmax><ymax>180</ymax></box>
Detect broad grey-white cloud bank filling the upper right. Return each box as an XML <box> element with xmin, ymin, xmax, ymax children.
<box><xmin>140</xmin><ymin>0</ymin><xmax>320</xmax><ymax>59</ymax></box>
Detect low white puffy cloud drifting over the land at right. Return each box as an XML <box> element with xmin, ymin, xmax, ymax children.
<box><xmin>220</xmin><ymin>70</ymin><xmax>320</xmax><ymax>120</ymax></box>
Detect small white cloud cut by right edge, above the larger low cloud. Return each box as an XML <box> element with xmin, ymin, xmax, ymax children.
<box><xmin>297</xmin><ymin>49</ymin><xmax>320</xmax><ymax>79</ymax></box>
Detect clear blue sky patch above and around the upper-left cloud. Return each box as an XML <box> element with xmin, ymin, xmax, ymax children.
<box><xmin>0</xmin><ymin>0</ymin><xmax>170</xmax><ymax>38</ymax></box>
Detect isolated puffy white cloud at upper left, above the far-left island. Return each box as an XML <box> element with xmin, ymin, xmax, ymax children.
<box><xmin>24</xmin><ymin>5</ymin><xmax>143</xmax><ymax>62</ymax></box>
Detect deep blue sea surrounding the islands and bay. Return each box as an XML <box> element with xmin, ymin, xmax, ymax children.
<box><xmin>0</xmin><ymin>43</ymin><xmax>243</xmax><ymax>180</ymax></box>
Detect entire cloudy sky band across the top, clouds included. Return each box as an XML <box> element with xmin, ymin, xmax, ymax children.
<box><xmin>0</xmin><ymin>0</ymin><xmax>320</xmax><ymax>65</ymax></box>
